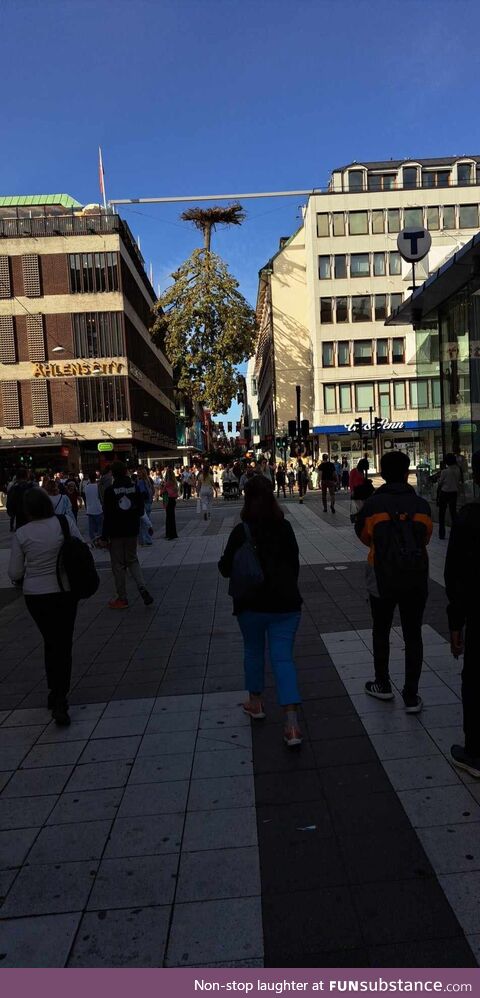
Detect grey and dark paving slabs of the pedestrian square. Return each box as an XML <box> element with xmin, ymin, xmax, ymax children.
<box><xmin>0</xmin><ymin>495</ymin><xmax>480</xmax><ymax>967</ymax></box>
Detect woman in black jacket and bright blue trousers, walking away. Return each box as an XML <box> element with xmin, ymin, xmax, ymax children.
<box><xmin>218</xmin><ymin>475</ymin><xmax>302</xmax><ymax>747</ymax></box>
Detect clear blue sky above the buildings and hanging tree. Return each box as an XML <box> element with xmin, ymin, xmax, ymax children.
<box><xmin>0</xmin><ymin>0</ymin><xmax>480</xmax><ymax>418</ymax></box>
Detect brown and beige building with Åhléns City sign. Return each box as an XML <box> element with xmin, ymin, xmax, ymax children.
<box><xmin>0</xmin><ymin>195</ymin><xmax>176</xmax><ymax>470</ymax></box>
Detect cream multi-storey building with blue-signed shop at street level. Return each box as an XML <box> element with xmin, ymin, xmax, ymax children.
<box><xmin>256</xmin><ymin>156</ymin><xmax>480</xmax><ymax>465</ymax></box>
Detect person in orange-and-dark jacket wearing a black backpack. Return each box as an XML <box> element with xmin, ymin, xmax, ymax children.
<box><xmin>355</xmin><ymin>451</ymin><xmax>432</xmax><ymax>714</ymax></box>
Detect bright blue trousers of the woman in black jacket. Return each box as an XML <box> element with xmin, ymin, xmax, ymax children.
<box><xmin>238</xmin><ymin>610</ymin><xmax>301</xmax><ymax>706</ymax></box>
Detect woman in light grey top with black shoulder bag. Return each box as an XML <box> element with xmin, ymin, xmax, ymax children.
<box><xmin>8</xmin><ymin>488</ymin><xmax>82</xmax><ymax>725</ymax></box>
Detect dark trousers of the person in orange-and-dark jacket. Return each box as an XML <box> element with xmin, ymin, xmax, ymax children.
<box><xmin>370</xmin><ymin>592</ymin><xmax>427</xmax><ymax>697</ymax></box>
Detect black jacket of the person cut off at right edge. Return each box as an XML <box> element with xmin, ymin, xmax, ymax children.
<box><xmin>445</xmin><ymin>502</ymin><xmax>480</xmax><ymax>631</ymax></box>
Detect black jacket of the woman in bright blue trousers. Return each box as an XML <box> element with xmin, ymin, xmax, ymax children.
<box><xmin>218</xmin><ymin>520</ymin><xmax>302</xmax><ymax>614</ymax></box>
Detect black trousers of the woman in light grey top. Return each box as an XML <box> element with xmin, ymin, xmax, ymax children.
<box><xmin>25</xmin><ymin>593</ymin><xmax>78</xmax><ymax>696</ymax></box>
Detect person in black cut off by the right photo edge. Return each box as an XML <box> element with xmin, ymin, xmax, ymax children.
<box><xmin>445</xmin><ymin>451</ymin><xmax>480</xmax><ymax>778</ymax></box>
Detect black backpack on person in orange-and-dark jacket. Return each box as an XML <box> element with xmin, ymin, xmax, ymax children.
<box><xmin>375</xmin><ymin>512</ymin><xmax>428</xmax><ymax>599</ymax></box>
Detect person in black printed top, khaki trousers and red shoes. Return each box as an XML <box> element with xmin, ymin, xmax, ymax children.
<box><xmin>102</xmin><ymin>461</ymin><xmax>153</xmax><ymax>610</ymax></box>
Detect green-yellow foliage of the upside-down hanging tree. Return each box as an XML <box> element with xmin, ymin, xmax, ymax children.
<box><xmin>152</xmin><ymin>249</ymin><xmax>255</xmax><ymax>413</ymax></box>
